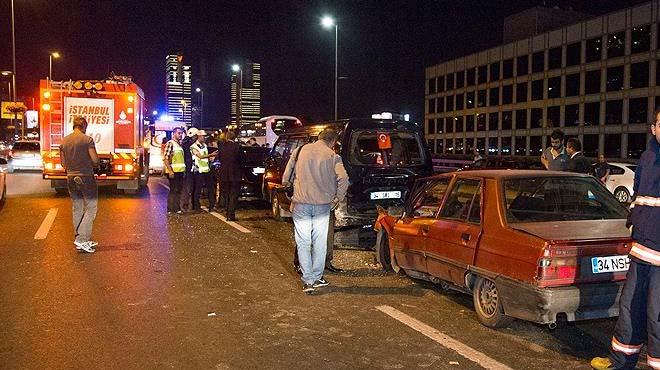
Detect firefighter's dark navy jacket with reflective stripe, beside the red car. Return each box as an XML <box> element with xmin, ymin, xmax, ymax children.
<box><xmin>631</xmin><ymin>138</ymin><xmax>660</xmax><ymax>262</ymax></box>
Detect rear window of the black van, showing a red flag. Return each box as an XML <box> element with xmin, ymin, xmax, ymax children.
<box><xmin>349</xmin><ymin>130</ymin><xmax>424</xmax><ymax>167</ymax></box>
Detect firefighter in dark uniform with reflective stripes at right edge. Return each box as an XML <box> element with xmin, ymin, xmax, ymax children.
<box><xmin>591</xmin><ymin>110</ymin><xmax>660</xmax><ymax>370</ymax></box>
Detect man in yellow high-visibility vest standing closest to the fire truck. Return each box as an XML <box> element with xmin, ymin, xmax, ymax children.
<box><xmin>163</xmin><ymin>127</ymin><xmax>186</xmax><ymax>215</ymax></box>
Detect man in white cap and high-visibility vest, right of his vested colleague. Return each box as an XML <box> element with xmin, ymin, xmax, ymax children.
<box><xmin>190</xmin><ymin>130</ymin><xmax>215</xmax><ymax>212</ymax></box>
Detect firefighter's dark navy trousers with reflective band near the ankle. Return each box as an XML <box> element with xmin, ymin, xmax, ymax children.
<box><xmin>610</xmin><ymin>260</ymin><xmax>660</xmax><ymax>370</ymax></box>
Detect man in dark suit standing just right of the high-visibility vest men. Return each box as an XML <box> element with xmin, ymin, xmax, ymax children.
<box><xmin>217</xmin><ymin>131</ymin><xmax>241</xmax><ymax>221</ymax></box>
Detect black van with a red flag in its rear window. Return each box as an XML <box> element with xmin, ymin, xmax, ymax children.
<box><xmin>263</xmin><ymin>119</ymin><xmax>433</xmax><ymax>228</ymax></box>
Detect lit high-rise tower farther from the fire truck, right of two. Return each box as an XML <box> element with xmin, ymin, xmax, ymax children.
<box><xmin>231</xmin><ymin>63</ymin><xmax>261</xmax><ymax>131</ymax></box>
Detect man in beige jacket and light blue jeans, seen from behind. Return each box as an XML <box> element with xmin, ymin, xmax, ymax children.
<box><xmin>282</xmin><ymin>128</ymin><xmax>348</xmax><ymax>293</ymax></box>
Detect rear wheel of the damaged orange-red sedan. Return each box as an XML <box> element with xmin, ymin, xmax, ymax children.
<box><xmin>472</xmin><ymin>277</ymin><xmax>512</xmax><ymax>328</ymax></box>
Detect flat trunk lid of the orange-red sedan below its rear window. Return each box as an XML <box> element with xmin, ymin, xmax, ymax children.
<box><xmin>509</xmin><ymin>219</ymin><xmax>630</xmax><ymax>240</ymax></box>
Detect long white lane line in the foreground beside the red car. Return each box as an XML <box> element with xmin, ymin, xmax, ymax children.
<box><xmin>376</xmin><ymin>306</ymin><xmax>513</xmax><ymax>370</ymax></box>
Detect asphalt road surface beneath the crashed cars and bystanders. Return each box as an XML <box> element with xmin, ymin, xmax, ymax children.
<box><xmin>0</xmin><ymin>173</ymin><xmax>646</xmax><ymax>370</ymax></box>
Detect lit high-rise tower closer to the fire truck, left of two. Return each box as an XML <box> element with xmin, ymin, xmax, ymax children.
<box><xmin>165</xmin><ymin>53</ymin><xmax>192</xmax><ymax>126</ymax></box>
